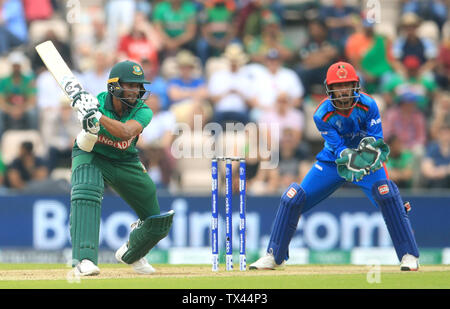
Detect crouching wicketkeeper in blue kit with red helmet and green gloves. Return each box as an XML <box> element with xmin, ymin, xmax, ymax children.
<box><xmin>249</xmin><ymin>62</ymin><xmax>419</xmax><ymax>271</ymax></box>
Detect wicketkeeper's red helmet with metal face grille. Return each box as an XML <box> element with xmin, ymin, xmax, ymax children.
<box><xmin>324</xmin><ymin>61</ymin><xmax>361</xmax><ymax>109</ymax></box>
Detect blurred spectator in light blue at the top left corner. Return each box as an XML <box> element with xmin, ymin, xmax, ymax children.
<box><xmin>0</xmin><ymin>0</ymin><xmax>28</xmax><ymax>56</ymax></box>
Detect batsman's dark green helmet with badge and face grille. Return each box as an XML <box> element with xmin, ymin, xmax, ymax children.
<box><xmin>108</xmin><ymin>60</ymin><xmax>150</xmax><ymax>107</ymax></box>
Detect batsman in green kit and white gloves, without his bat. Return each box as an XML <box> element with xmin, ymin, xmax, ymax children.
<box><xmin>70</xmin><ymin>61</ymin><xmax>174</xmax><ymax>276</ymax></box>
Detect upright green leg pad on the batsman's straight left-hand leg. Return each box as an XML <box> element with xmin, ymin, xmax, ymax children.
<box><xmin>70</xmin><ymin>164</ymin><xmax>104</xmax><ymax>265</ymax></box>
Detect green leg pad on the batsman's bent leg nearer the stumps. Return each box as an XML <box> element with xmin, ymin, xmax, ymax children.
<box><xmin>122</xmin><ymin>210</ymin><xmax>175</xmax><ymax>264</ymax></box>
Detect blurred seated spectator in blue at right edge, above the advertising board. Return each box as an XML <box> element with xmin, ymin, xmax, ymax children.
<box><xmin>421</xmin><ymin>115</ymin><xmax>450</xmax><ymax>189</ymax></box>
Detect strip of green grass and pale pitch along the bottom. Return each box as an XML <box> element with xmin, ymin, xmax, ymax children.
<box><xmin>0</xmin><ymin>264</ymin><xmax>450</xmax><ymax>289</ymax></box>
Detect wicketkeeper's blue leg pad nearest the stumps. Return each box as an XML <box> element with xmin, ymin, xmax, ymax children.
<box><xmin>267</xmin><ymin>183</ymin><xmax>306</xmax><ymax>265</ymax></box>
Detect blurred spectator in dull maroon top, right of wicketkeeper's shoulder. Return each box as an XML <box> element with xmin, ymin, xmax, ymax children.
<box><xmin>383</xmin><ymin>93</ymin><xmax>427</xmax><ymax>156</ymax></box>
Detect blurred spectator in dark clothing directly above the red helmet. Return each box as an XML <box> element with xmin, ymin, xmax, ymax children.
<box><xmin>319</xmin><ymin>0</ymin><xmax>360</xmax><ymax>53</ymax></box>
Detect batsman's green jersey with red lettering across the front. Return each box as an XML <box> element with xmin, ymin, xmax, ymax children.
<box><xmin>72</xmin><ymin>92</ymin><xmax>153</xmax><ymax>161</ymax></box>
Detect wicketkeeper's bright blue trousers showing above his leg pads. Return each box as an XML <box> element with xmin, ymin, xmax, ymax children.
<box><xmin>300</xmin><ymin>161</ymin><xmax>388</xmax><ymax>213</ymax></box>
